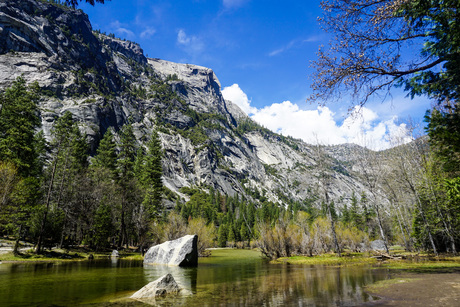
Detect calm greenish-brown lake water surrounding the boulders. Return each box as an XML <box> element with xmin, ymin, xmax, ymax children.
<box><xmin>0</xmin><ymin>250</ymin><xmax>390</xmax><ymax>306</ymax></box>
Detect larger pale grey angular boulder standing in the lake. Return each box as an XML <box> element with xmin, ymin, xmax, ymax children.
<box><xmin>144</xmin><ymin>235</ymin><xmax>198</xmax><ymax>266</ymax></box>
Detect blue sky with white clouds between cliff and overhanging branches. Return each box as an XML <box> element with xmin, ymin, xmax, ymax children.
<box><xmin>80</xmin><ymin>0</ymin><xmax>430</xmax><ymax>149</ymax></box>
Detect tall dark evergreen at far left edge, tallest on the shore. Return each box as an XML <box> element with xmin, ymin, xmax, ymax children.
<box><xmin>0</xmin><ymin>77</ymin><xmax>44</xmax><ymax>253</ymax></box>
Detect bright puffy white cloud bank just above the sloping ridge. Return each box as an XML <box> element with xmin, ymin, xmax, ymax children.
<box><xmin>222</xmin><ymin>84</ymin><xmax>411</xmax><ymax>150</ymax></box>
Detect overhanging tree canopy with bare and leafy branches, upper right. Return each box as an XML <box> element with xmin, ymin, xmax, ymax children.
<box><xmin>310</xmin><ymin>0</ymin><xmax>460</xmax><ymax>105</ymax></box>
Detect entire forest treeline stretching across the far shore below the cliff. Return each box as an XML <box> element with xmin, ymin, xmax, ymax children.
<box><xmin>0</xmin><ymin>78</ymin><xmax>460</xmax><ymax>258</ymax></box>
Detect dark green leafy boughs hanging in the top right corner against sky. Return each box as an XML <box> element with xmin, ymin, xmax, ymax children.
<box><xmin>397</xmin><ymin>0</ymin><xmax>460</xmax><ymax>104</ymax></box>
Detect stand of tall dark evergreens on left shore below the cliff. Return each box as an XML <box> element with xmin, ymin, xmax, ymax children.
<box><xmin>0</xmin><ymin>78</ymin><xmax>164</xmax><ymax>253</ymax></box>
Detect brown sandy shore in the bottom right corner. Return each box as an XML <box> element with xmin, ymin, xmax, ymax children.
<box><xmin>365</xmin><ymin>271</ymin><xmax>460</xmax><ymax>307</ymax></box>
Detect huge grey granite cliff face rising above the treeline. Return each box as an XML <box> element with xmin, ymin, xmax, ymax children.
<box><xmin>0</xmin><ymin>0</ymin><xmax>374</xmax><ymax>209</ymax></box>
